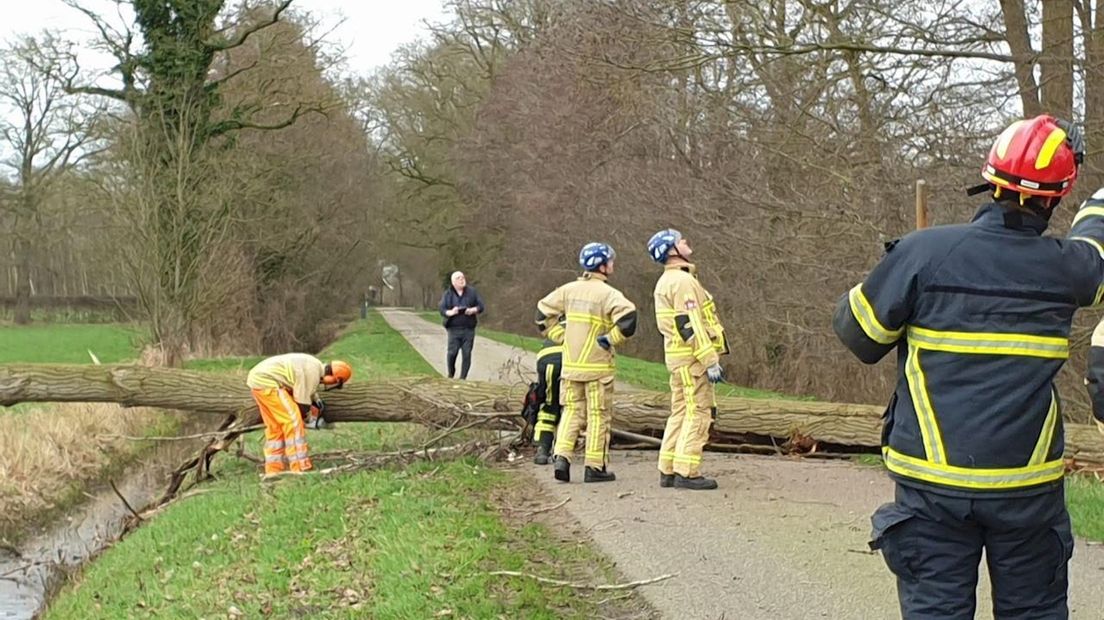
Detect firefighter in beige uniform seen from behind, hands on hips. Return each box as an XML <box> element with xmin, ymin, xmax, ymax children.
<box><xmin>537</xmin><ymin>243</ymin><xmax>636</xmax><ymax>482</ymax></box>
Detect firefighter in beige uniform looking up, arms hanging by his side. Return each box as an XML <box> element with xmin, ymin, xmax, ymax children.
<box><xmin>648</xmin><ymin>228</ymin><xmax>729</xmax><ymax>490</ymax></box>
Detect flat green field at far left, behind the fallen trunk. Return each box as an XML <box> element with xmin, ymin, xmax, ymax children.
<box><xmin>0</xmin><ymin>324</ymin><xmax>140</xmax><ymax>364</ymax></box>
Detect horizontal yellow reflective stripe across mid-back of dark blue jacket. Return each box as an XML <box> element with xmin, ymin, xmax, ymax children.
<box><xmin>909</xmin><ymin>327</ymin><xmax>1070</xmax><ymax>360</ymax></box>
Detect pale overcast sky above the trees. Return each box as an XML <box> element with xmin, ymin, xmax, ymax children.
<box><xmin>0</xmin><ymin>0</ymin><xmax>444</xmax><ymax>74</ymax></box>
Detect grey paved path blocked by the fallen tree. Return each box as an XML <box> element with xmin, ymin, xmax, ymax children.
<box><xmin>381</xmin><ymin>309</ymin><xmax>1104</xmax><ymax>620</ymax></box>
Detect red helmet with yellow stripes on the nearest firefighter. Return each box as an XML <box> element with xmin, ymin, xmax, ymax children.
<box><xmin>981</xmin><ymin>115</ymin><xmax>1084</xmax><ymax>196</ymax></box>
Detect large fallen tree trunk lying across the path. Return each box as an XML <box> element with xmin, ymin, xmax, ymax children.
<box><xmin>0</xmin><ymin>364</ymin><xmax>1104</xmax><ymax>462</ymax></box>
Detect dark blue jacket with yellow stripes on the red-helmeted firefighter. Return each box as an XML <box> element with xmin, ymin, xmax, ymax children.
<box><xmin>834</xmin><ymin>200</ymin><xmax>1104</xmax><ymax>496</ymax></box>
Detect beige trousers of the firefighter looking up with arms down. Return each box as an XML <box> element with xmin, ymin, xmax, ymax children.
<box><xmin>659</xmin><ymin>366</ymin><xmax>716</xmax><ymax>478</ymax></box>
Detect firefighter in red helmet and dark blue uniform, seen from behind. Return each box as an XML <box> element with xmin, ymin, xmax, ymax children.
<box><xmin>834</xmin><ymin>115</ymin><xmax>1104</xmax><ymax>619</ymax></box>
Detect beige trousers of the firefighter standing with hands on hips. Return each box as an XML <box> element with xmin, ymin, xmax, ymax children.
<box><xmin>555</xmin><ymin>376</ymin><xmax>614</xmax><ymax>469</ymax></box>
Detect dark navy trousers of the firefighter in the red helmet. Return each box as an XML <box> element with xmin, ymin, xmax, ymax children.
<box><xmin>870</xmin><ymin>484</ymin><xmax>1073</xmax><ymax>620</ymax></box>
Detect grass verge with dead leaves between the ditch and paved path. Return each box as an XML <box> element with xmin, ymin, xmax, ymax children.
<box><xmin>45</xmin><ymin>314</ymin><xmax>647</xmax><ymax>619</ymax></box>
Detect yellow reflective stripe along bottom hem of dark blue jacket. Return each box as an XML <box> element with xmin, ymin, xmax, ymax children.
<box><xmin>882</xmin><ymin>446</ymin><xmax>1065</xmax><ymax>490</ymax></box>
